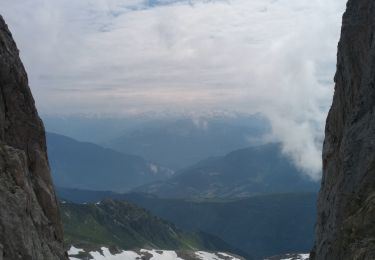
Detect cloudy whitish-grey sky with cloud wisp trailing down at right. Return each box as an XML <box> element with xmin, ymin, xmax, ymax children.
<box><xmin>0</xmin><ymin>0</ymin><xmax>346</xmax><ymax>179</ymax></box>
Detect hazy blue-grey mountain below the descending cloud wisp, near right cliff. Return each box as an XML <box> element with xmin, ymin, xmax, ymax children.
<box><xmin>134</xmin><ymin>144</ymin><xmax>319</xmax><ymax>199</ymax></box>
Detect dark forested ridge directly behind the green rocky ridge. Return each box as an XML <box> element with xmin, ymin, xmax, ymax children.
<box><xmin>57</xmin><ymin>188</ymin><xmax>317</xmax><ymax>259</ymax></box>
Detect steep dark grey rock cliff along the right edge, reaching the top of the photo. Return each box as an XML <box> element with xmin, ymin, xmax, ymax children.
<box><xmin>312</xmin><ymin>0</ymin><xmax>375</xmax><ymax>259</ymax></box>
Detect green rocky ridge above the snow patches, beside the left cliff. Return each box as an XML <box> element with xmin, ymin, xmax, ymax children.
<box><xmin>61</xmin><ymin>200</ymin><xmax>251</xmax><ymax>255</ymax></box>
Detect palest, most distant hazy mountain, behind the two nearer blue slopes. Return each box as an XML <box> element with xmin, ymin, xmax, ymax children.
<box><xmin>106</xmin><ymin>116</ymin><xmax>269</xmax><ymax>170</ymax></box>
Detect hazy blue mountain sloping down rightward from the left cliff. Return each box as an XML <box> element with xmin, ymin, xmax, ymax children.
<box><xmin>47</xmin><ymin>133</ymin><xmax>174</xmax><ymax>192</ymax></box>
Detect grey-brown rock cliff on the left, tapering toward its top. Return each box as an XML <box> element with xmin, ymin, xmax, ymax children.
<box><xmin>0</xmin><ymin>16</ymin><xmax>67</xmax><ymax>260</ymax></box>
